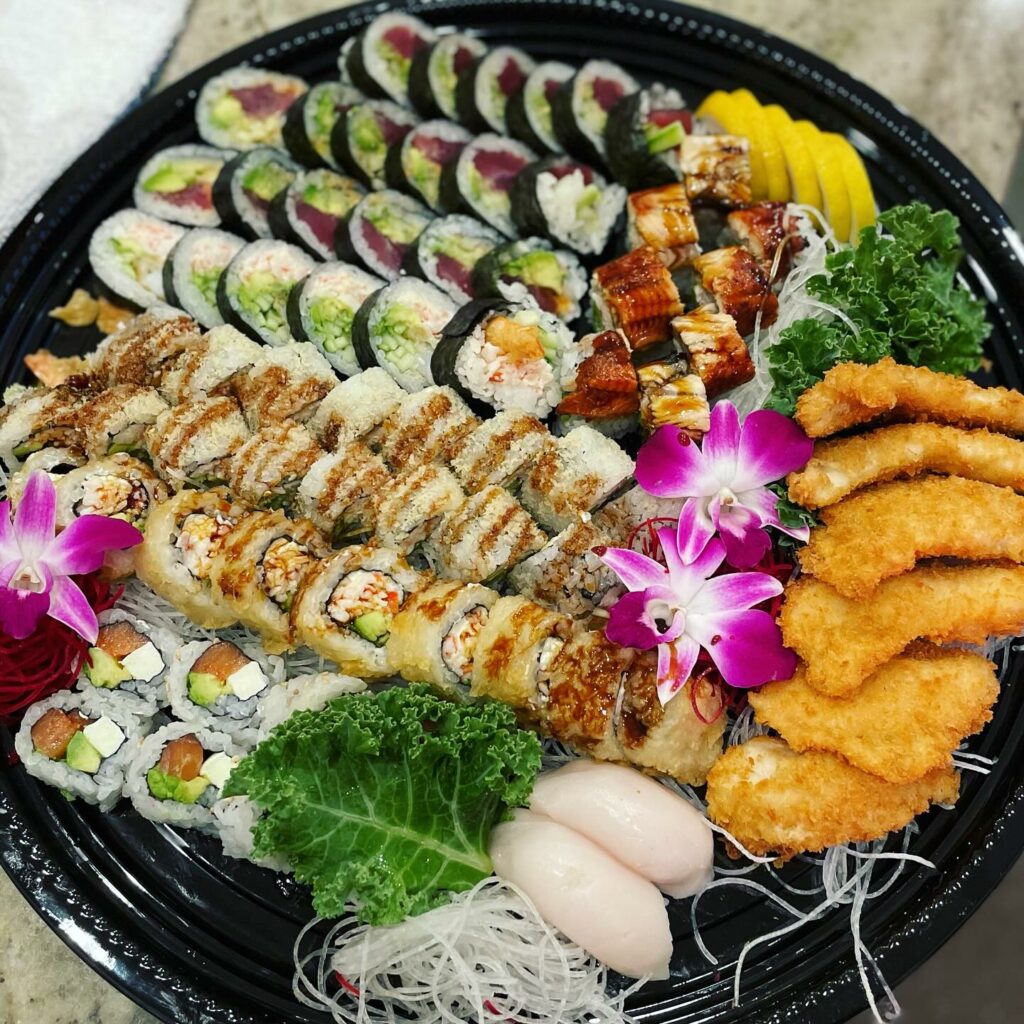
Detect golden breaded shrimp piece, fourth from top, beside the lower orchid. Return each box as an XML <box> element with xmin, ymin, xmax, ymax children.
<box><xmin>779</xmin><ymin>565</ymin><xmax>1024</xmax><ymax>697</ymax></box>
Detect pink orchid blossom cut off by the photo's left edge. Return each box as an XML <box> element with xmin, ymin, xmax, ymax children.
<box><xmin>0</xmin><ymin>471</ymin><xmax>142</xmax><ymax>643</ymax></box>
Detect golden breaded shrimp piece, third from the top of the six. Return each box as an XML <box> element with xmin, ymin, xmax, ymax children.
<box><xmin>800</xmin><ymin>476</ymin><xmax>1024</xmax><ymax>597</ymax></box>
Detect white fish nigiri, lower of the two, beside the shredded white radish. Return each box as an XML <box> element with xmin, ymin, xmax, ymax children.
<box><xmin>490</xmin><ymin>810</ymin><xmax>672</xmax><ymax>979</ymax></box>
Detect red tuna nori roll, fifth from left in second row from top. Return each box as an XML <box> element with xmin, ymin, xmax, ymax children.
<box><xmin>441</xmin><ymin>134</ymin><xmax>537</xmax><ymax>239</ymax></box>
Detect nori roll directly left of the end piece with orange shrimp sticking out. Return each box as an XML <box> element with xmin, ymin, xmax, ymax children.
<box><xmin>352</xmin><ymin>278</ymin><xmax>456</xmax><ymax>391</ymax></box>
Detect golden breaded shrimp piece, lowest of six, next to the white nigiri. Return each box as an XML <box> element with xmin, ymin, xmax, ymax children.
<box><xmin>708</xmin><ymin>736</ymin><xmax>959</xmax><ymax>860</ymax></box>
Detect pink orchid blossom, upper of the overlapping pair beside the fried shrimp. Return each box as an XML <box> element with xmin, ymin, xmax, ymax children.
<box><xmin>636</xmin><ymin>401</ymin><xmax>814</xmax><ymax>569</ymax></box>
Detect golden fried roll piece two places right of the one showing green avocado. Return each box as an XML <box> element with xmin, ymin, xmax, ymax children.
<box><xmin>469</xmin><ymin>595</ymin><xmax>572</xmax><ymax>723</ymax></box>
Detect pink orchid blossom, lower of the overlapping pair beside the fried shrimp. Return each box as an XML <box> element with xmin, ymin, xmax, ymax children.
<box><xmin>600</xmin><ymin>528</ymin><xmax>797</xmax><ymax>705</ymax></box>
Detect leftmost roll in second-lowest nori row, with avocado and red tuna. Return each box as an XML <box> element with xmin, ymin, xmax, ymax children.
<box><xmin>132</xmin><ymin>145</ymin><xmax>234</xmax><ymax>227</ymax></box>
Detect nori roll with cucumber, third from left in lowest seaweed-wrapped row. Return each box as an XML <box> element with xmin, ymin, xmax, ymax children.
<box><xmin>217</xmin><ymin>241</ymin><xmax>315</xmax><ymax>345</ymax></box>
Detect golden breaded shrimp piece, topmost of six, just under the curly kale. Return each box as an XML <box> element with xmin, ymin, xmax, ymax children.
<box><xmin>797</xmin><ymin>358</ymin><xmax>1024</xmax><ymax>437</ymax></box>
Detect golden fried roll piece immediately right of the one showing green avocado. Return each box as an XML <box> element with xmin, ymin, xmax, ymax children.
<box><xmin>388</xmin><ymin>582</ymin><xmax>498</xmax><ymax>693</ymax></box>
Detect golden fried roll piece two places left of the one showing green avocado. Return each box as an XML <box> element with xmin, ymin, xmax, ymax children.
<box><xmin>135</xmin><ymin>487</ymin><xmax>242</xmax><ymax>630</ymax></box>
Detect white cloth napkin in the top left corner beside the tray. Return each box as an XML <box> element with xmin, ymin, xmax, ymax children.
<box><xmin>0</xmin><ymin>0</ymin><xmax>188</xmax><ymax>242</ymax></box>
